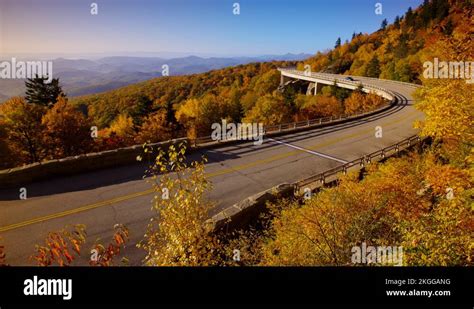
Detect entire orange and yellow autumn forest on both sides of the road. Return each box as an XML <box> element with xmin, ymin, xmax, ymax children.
<box><xmin>0</xmin><ymin>0</ymin><xmax>474</xmax><ymax>266</ymax></box>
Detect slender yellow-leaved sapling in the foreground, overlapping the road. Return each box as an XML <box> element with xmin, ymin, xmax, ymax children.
<box><xmin>139</xmin><ymin>144</ymin><xmax>217</xmax><ymax>266</ymax></box>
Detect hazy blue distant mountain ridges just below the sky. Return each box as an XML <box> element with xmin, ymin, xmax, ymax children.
<box><xmin>0</xmin><ymin>53</ymin><xmax>311</xmax><ymax>102</ymax></box>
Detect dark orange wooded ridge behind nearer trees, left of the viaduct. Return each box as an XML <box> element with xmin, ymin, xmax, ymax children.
<box><xmin>73</xmin><ymin>62</ymin><xmax>288</xmax><ymax>128</ymax></box>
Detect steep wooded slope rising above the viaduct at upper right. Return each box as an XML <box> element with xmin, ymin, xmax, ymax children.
<box><xmin>298</xmin><ymin>0</ymin><xmax>472</xmax><ymax>83</ymax></box>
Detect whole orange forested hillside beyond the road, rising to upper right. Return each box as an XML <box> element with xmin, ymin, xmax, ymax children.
<box><xmin>0</xmin><ymin>0</ymin><xmax>473</xmax><ymax>168</ymax></box>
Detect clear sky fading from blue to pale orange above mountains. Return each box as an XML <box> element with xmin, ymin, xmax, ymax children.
<box><xmin>0</xmin><ymin>0</ymin><xmax>422</xmax><ymax>56</ymax></box>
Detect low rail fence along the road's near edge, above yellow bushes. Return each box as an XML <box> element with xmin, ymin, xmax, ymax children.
<box><xmin>295</xmin><ymin>135</ymin><xmax>422</xmax><ymax>192</ymax></box>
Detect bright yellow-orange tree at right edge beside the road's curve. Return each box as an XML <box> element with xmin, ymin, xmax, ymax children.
<box><xmin>415</xmin><ymin>17</ymin><xmax>474</xmax><ymax>151</ymax></box>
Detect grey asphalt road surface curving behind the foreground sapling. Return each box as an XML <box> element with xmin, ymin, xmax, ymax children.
<box><xmin>0</xmin><ymin>73</ymin><xmax>423</xmax><ymax>265</ymax></box>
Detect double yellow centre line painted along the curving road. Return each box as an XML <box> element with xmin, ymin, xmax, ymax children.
<box><xmin>0</xmin><ymin>111</ymin><xmax>416</xmax><ymax>232</ymax></box>
